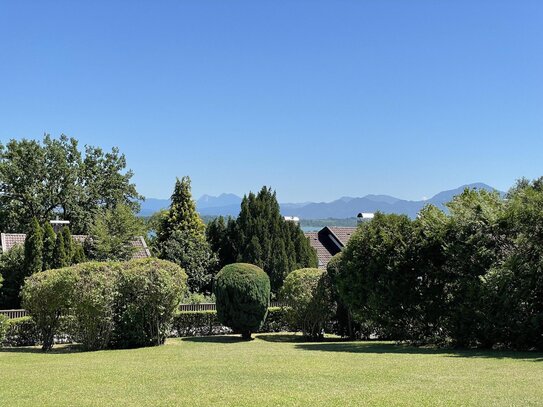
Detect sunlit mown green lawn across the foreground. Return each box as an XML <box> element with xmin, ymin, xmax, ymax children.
<box><xmin>0</xmin><ymin>335</ymin><xmax>543</xmax><ymax>406</ymax></box>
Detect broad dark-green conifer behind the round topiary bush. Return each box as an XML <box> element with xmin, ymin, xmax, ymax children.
<box><xmin>207</xmin><ymin>187</ymin><xmax>317</xmax><ymax>293</ymax></box>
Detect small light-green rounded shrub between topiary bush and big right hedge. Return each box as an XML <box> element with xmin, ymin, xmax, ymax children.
<box><xmin>280</xmin><ymin>268</ymin><xmax>333</xmax><ymax>338</ymax></box>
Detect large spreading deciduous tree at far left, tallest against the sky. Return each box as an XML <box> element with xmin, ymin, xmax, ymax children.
<box><xmin>0</xmin><ymin>135</ymin><xmax>141</xmax><ymax>234</ymax></box>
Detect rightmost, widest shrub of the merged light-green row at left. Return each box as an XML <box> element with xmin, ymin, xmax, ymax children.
<box><xmin>110</xmin><ymin>258</ymin><xmax>187</xmax><ymax>348</ymax></box>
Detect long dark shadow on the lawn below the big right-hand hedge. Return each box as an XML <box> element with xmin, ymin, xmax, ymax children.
<box><xmin>296</xmin><ymin>342</ymin><xmax>543</xmax><ymax>362</ymax></box>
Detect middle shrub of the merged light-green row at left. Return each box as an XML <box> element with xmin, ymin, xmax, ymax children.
<box><xmin>71</xmin><ymin>262</ymin><xmax>118</xmax><ymax>349</ymax></box>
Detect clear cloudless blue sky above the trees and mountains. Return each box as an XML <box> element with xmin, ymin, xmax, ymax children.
<box><xmin>0</xmin><ymin>0</ymin><xmax>543</xmax><ymax>202</ymax></box>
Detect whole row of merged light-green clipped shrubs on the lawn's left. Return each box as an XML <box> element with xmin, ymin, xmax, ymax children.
<box><xmin>22</xmin><ymin>259</ymin><xmax>187</xmax><ymax>350</ymax></box>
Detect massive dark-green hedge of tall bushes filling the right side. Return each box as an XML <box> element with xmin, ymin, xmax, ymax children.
<box><xmin>333</xmin><ymin>179</ymin><xmax>543</xmax><ymax>349</ymax></box>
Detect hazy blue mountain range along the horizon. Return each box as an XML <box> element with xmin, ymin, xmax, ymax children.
<box><xmin>140</xmin><ymin>182</ymin><xmax>504</xmax><ymax>219</ymax></box>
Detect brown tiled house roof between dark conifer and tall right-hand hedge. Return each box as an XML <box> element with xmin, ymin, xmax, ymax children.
<box><xmin>305</xmin><ymin>226</ymin><xmax>356</xmax><ymax>268</ymax></box>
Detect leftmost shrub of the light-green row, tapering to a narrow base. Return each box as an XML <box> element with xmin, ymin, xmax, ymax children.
<box><xmin>22</xmin><ymin>268</ymin><xmax>77</xmax><ymax>351</ymax></box>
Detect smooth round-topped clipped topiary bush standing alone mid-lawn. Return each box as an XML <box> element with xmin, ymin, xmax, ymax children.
<box><xmin>214</xmin><ymin>263</ymin><xmax>270</xmax><ymax>339</ymax></box>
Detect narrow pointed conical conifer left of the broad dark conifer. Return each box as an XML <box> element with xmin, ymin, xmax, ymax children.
<box><xmin>152</xmin><ymin>177</ymin><xmax>217</xmax><ymax>293</ymax></box>
